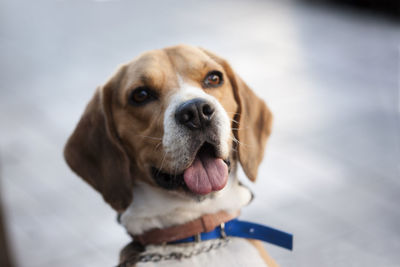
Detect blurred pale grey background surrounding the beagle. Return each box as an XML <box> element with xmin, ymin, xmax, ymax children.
<box><xmin>0</xmin><ymin>0</ymin><xmax>400</xmax><ymax>267</ymax></box>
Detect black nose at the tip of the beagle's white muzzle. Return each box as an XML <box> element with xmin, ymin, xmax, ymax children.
<box><xmin>175</xmin><ymin>98</ymin><xmax>215</xmax><ymax>130</ymax></box>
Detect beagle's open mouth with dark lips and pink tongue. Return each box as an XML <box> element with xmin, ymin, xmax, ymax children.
<box><xmin>151</xmin><ymin>142</ymin><xmax>230</xmax><ymax>195</ymax></box>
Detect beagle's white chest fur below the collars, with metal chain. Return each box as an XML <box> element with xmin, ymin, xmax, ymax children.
<box><xmin>136</xmin><ymin>238</ymin><xmax>268</xmax><ymax>267</ymax></box>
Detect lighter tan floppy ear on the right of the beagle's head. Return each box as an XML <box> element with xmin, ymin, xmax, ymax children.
<box><xmin>203</xmin><ymin>49</ymin><xmax>272</xmax><ymax>182</ymax></box>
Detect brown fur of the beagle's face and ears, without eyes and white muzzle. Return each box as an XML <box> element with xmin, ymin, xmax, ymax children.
<box><xmin>64</xmin><ymin>45</ymin><xmax>272</xmax><ymax>211</ymax></box>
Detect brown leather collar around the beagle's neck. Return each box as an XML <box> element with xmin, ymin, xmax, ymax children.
<box><xmin>133</xmin><ymin>211</ymin><xmax>239</xmax><ymax>245</ymax></box>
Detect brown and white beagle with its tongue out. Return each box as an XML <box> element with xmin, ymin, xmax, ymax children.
<box><xmin>64</xmin><ymin>45</ymin><xmax>277</xmax><ymax>267</ymax></box>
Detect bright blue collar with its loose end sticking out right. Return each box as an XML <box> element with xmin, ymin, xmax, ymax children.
<box><xmin>169</xmin><ymin>219</ymin><xmax>293</xmax><ymax>250</ymax></box>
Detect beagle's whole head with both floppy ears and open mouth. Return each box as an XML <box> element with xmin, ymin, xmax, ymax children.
<box><xmin>64</xmin><ymin>46</ymin><xmax>272</xmax><ymax>211</ymax></box>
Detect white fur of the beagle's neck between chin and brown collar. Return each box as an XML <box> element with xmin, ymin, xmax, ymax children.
<box><xmin>121</xmin><ymin>177</ymin><xmax>252</xmax><ymax>235</ymax></box>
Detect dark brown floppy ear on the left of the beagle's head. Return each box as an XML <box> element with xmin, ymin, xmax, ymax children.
<box><xmin>64</xmin><ymin>78</ymin><xmax>132</xmax><ymax>212</ymax></box>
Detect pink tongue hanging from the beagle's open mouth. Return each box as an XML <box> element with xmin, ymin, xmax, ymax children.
<box><xmin>183</xmin><ymin>154</ymin><xmax>228</xmax><ymax>195</ymax></box>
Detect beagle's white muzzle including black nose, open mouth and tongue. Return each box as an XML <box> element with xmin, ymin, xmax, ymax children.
<box><xmin>151</xmin><ymin>97</ymin><xmax>229</xmax><ymax>195</ymax></box>
